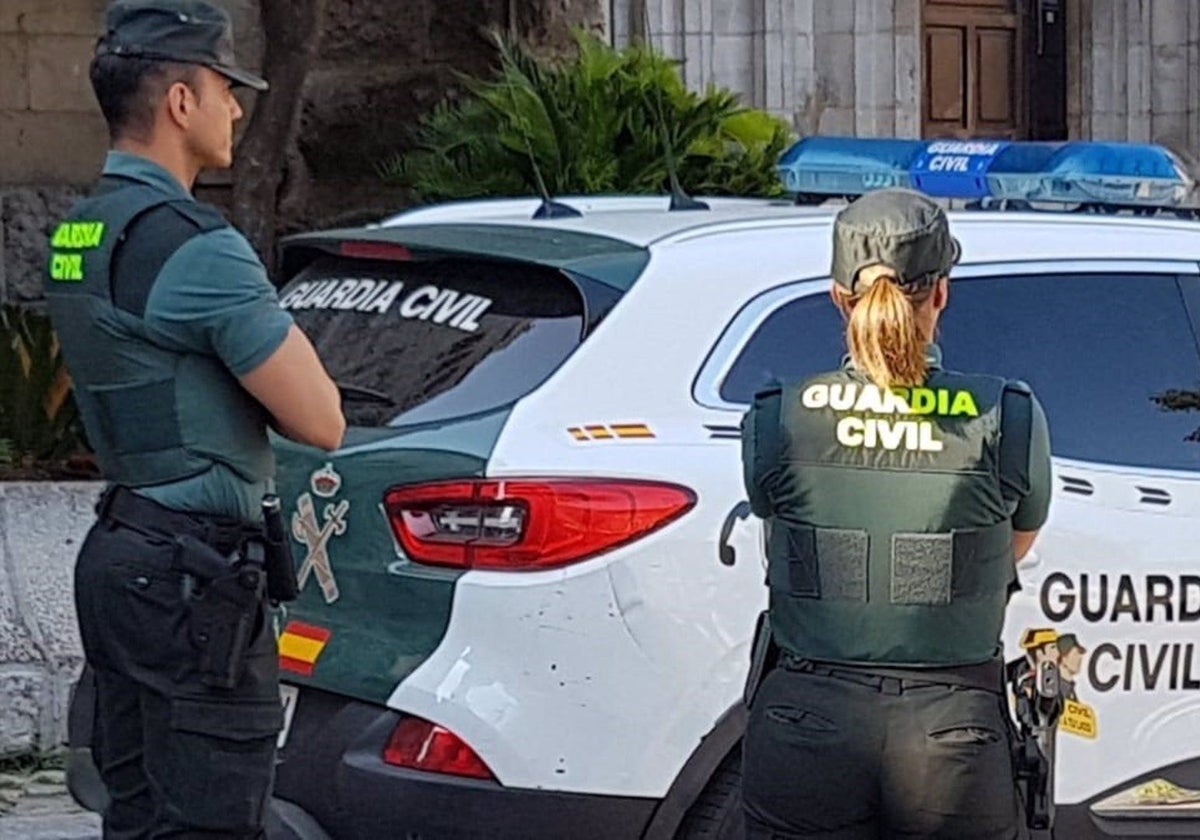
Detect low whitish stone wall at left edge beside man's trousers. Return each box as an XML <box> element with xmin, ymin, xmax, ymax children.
<box><xmin>0</xmin><ymin>482</ymin><xmax>100</xmax><ymax>757</ymax></box>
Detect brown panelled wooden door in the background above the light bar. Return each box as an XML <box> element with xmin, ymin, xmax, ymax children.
<box><xmin>922</xmin><ymin>0</ymin><xmax>1026</xmax><ymax>139</ymax></box>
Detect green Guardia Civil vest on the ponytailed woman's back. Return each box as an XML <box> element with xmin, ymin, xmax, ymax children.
<box><xmin>767</xmin><ymin>370</ymin><xmax>1015</xmax><ymax>667</ymax></box>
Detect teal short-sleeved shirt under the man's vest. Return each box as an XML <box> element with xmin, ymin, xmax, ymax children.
<box><xmin>104</xmin><ymin>151</ymin><xmax>292</xmax><ymax>521</ymax></box>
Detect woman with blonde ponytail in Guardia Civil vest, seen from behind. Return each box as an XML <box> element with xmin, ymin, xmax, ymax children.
<box><xmin>743</xmin><ymin>190</ymin><xmax>1050</xmax><ymax>840</ymax></box>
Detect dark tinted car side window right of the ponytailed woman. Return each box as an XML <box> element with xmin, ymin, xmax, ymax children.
<box><xmin>940</xmin><ymin>274</ymin><xmax>1200</xmax><ymax>469</ymax></box>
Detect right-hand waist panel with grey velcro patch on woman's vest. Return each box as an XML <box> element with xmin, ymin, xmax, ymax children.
<box><xmin>892</xmin><ymin>520</ymin><xmax>1012</xmax><ymax>606</ymax></box>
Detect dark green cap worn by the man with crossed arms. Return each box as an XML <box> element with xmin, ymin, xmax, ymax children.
<box><xmin>96</xmin><ymin>0</ymin><xmax>268</xmax><ymax>90</ymax></box>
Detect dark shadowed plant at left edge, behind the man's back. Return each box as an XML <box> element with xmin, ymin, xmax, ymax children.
<box><xmin>0</xmin><ymin>305</ymin><xmax>85</xmax><ymax>467</ymax></box>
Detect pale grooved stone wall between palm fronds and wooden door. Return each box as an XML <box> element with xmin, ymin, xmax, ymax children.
<box><xmin>612</xmin><ymin>0</ymin><xmax>920</xmax><ymax>137</ymax></box>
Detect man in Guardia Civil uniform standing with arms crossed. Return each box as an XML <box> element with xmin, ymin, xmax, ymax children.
<box><xmin>47</xmin><ymin>0</ymin><xmax>346</xmax><ymax>838</ymax></box>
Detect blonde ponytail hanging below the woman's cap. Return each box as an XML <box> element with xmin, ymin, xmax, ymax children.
<box><xmin>846</xmin><ymin>276</ymin><xmax>929</xmax><ymax>388</ymax></box>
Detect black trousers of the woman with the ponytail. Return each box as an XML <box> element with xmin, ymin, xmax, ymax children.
<box><xmin>743</xmin><ymin>662</ymin><xmax>1024</xmax><ymax>840</ymax></box>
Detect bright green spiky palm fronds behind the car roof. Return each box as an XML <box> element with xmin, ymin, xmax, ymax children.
<box><xmin>382</xmin><ymin>31</ymin><xmax>794</xmax><ymax>202</ymax></box>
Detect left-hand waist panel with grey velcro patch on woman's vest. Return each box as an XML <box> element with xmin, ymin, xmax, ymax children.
<box><xmin>770</xmin><ymin>526</ymin><xmax>870</xmax><ymax>601</ymax></box>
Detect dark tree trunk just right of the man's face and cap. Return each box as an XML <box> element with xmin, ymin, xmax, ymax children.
<box><xmin>232</xmin><ymin>0</ymin><xmax>324</xmax><ymax>266</ymax></box>
